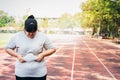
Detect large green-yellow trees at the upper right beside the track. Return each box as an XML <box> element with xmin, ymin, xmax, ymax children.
<box><xmin>81</xmin><ymin>0</ymin><xmax>120</xmax><ymax>37</ymax></box>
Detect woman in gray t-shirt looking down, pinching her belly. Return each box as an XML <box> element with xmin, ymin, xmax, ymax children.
<box><xmin>5</xmin><ymin>15</ymin><xmax>56</xmax><ymax>80</ymax></box>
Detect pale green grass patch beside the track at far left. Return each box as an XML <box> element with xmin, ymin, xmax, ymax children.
<box><xmin>0</xmin><ymin>33</ymin><xmax>13</xmax><ymax>48</ymax></box>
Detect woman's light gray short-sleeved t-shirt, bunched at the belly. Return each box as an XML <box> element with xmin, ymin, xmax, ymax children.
<box><xmin>6</xmin><ymin>31</ymin><xmax>55</xmax><ymax>77</ymax></box>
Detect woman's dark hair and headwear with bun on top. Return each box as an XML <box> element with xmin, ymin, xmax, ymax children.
<box><xmin>24</xmin><ymin>15</ymin><xmax>38</xmax><ymax>32</ymax></box>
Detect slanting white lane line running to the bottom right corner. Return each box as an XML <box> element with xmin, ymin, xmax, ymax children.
<box><xmin>83</xmin><ymin>41</ymin><xmax>117</xmax><ymax>80</ymax></box>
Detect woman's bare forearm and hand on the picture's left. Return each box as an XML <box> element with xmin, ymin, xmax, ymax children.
<box><xmin>5</xmin><ymin>49</ymin><xmax>25</xmax><ymax>63</ymax></box>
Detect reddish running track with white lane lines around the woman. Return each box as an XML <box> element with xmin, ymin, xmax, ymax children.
<box><xmin>0</xmin><ymin>35</ymin><xmax>120</xmax><ymax>80</ymax></box>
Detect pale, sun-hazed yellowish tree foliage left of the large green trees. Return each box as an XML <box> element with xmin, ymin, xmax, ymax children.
<box><xmin>58</xmin><ymin>13</ymin><xmax>81</xmax><ymax>29</ymax></box>
